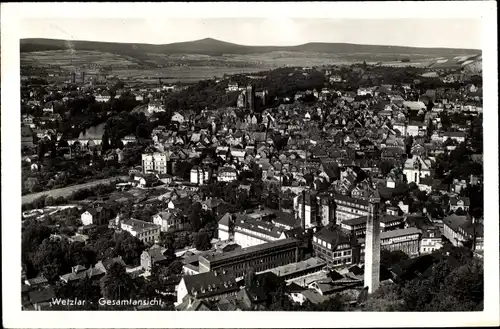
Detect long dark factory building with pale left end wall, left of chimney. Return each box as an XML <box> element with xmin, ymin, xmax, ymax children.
<box><xmin>199</xmin><ymin>238</ymin><xmax>300</xmax><ymax>277</ymax></box>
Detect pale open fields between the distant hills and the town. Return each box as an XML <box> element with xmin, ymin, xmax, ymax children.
<box><xmin>21</xmin><ymin>50</ymin><xmax>478</xmax><ymax>83</ymax></box>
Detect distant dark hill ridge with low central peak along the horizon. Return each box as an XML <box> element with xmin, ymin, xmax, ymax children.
<box><xmin>20</xmin><ymin>38</ymin><xmax>481</xmax><ymax>56</ymax></box>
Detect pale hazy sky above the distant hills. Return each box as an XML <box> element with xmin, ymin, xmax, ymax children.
<box><xmin>20</xmin><ymin>18</ymin><xmax>482</xmax><ymax>49</ymax></box>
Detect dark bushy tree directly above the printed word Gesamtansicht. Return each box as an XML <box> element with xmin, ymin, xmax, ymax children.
<box><xmin>100</xmin><ymin>263</ymin><xmax>133</xmax><ymax>300</ymax></box>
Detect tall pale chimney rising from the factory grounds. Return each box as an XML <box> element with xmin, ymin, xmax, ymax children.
<box><xmin>365</xmin><ymin>191</ymin><xmax>380</xmax><ymax>294</ymax></box>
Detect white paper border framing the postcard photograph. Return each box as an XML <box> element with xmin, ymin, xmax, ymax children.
<box><xmin>1</xmin><ymin>1</ymin><xmax>500</xmax><ymax>328</ymax></box>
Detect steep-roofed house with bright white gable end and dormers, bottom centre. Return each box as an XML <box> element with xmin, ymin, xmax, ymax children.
<box><xmin>177</xmin><ymin>272</ymin><xmax>240</xmax><ymax>305</ymax></box>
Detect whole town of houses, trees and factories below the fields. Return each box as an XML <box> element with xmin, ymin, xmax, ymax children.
<box><xmin>20</xmin><ymin>58</ymin><xmax>484</xmax><ymax>311</ymax></box>
